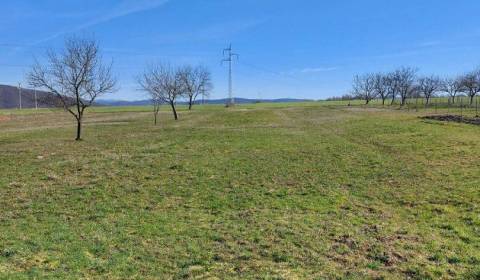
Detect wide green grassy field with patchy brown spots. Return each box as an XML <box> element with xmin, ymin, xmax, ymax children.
<box><xmin>0</xmin><ymin>103</ymin><xmax>480</xmax><ymax>279</ymax></box>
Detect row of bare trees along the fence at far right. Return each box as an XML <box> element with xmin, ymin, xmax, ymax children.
<box><xmin>352</xmin><ymin>67</ymin><xmax>480</xmax><ymax>106</ymax></box>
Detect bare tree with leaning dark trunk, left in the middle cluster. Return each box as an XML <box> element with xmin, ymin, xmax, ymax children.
<box><xmin>137</xmin><ymin>63</ymin><xmax>185</xmax><ymax>120</ymax></box>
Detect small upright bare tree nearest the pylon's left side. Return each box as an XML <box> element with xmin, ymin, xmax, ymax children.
<box><xmin>179</xmin><ymin>66</ymin><xmax>212</xmax><ymax>110</ymax></box>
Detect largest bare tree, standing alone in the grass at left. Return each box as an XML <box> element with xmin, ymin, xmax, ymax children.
<box><xmin>27</xmin><ymin>37</ymin><xmax>116</xmax><ymax>140</ymax></box>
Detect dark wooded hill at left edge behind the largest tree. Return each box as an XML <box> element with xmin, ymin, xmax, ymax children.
<box><xmin>0</xmin><ymin>85</ymin><xmax>50</xmax><ymax>109</ymax></box>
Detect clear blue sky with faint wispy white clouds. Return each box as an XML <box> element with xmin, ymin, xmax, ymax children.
<box><xmin>0</xmin><ymin>0</ymin><xmax>480</xmax><ymax>100</ymax></box>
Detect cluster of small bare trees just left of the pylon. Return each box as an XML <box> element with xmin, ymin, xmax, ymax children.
<box><xmin>137</xmin><ymin>63</ymin><xmax>212</xmax><ymax>124</ymax></box>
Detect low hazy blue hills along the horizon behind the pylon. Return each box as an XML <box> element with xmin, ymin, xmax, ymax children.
<box><xmin>96</xmin><ymin>98</ymin><xmax>313</xmax><ymax>106</ymax></box>
